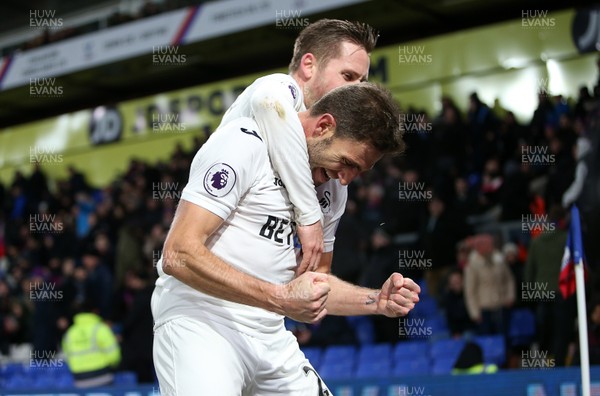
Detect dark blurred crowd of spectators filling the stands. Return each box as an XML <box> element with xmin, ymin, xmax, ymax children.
<box><xmin>0</xmin><ymin>77</ymin><xmax>600</xmax><ymax>382</ymax></box>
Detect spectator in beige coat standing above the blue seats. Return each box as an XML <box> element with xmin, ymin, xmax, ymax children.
<box><xmin>465</xmin><ymin>234</ymin><xmax>515</xmax><ymax>335</ymax></box>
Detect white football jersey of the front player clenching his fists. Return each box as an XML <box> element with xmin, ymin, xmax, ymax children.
<box><xmin>152</xmin><ymin>118</ymin><xmax>296</xmax><ymax>335</ymax></box>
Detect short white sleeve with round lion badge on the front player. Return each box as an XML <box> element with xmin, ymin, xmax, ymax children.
<box><xmin>181</xmin><ymin>118</ymin><xmax>266</xmax><ymax>220</ymax></box>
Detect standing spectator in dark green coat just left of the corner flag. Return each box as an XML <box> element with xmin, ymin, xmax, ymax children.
<box><xmin>523</xmin><ymin>205</ymin><xmax>576</xmax><ymax>366</ymax></box>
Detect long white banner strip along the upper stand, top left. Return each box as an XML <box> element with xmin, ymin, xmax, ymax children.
<box><xmin>0</xmin><ymin>0</ymin><xmax>366</xmax><ymax>91</ymax></box>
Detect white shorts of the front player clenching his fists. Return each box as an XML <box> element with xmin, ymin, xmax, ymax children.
<box><xmin>153</xmin><ymin>317</ymin><xmax>332</xmax><ymax>396</ymax></box>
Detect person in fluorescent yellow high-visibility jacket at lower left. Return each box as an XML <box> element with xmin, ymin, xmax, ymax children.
<box><xmin>62</xmin><ymin>301</ymin><xmax>121</xmax><ymax>388</ymax></box>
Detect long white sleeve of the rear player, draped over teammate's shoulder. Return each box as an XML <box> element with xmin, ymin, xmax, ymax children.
<box><xmin>224</xmin><ymin>74</ymin><xmax>321</xmax><ymax>225</ymax></box>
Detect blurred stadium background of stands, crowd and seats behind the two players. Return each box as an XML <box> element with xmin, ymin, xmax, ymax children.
<box><xmin>0</xmin><ymin>0</ymin><xmax>600</xmax><ymax>396</ymax></box>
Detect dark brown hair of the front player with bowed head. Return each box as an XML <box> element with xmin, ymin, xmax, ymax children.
<box><xmin>309</xmin><ymin>82</ymin><xmax>405</xmax><ymax>154</ymax></box>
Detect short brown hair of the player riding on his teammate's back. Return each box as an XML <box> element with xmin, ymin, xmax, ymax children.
<box><xmin>289</xmin><ymin>19</ymin><xmax>379</xmax><ymax>73</ymax></box>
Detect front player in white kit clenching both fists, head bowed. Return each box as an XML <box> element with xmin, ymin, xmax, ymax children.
<box><xmin>152</xmin><ymin>83</ymin><xmax>420</xmax><ymax>396</ymax></box>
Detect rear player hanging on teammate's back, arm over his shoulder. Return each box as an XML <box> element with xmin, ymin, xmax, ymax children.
<box><xmin>221</xmin><ymin>19</ymin><xmax>378</xmax><ymax>273</ymax></box>
